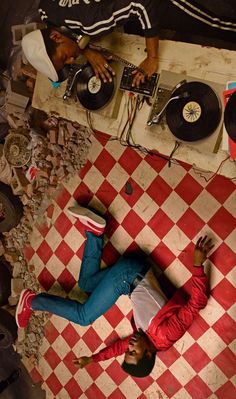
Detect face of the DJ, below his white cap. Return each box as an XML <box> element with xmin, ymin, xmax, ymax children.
<box><xmin>50</xmin><ymin>30</ymin><xmax>79</xmax><ymax>71</ymax></box>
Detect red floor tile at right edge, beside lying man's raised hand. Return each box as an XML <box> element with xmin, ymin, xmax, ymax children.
<box><xmin>210</xmin><ymin>242</ymin><xmax>236</xmax><ymax>275</ymax></box>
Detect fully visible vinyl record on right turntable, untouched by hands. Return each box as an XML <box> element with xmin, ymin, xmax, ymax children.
<box><xmin>166</xmin><ymin>82</ymin><xmax>221</xmax><ymax>141</ymax></box>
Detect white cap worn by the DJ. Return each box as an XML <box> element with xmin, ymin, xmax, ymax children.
<box><xmin>21</xmin><ymin>29</ymin><xmax>58</xmax><ymax>82</ymax></box>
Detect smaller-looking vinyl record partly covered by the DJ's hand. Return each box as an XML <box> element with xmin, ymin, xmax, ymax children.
<box><xmin>76</xmin><ymin>65</ymin><xmax>114</xmax><ymax>111</ymax></box>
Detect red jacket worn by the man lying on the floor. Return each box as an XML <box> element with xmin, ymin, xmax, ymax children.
<box><xmin>92</xmin><ymin>266</ymin><xmax>207</xmax><ymax>362</ymax></box>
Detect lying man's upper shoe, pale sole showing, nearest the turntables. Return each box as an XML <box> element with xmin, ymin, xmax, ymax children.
<box><xmin>68</xmin><ymin>206</ymin><xmax>106</xmax><ymax>234</ymax></box>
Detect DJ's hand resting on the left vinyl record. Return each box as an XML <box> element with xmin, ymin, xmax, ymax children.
<box><xmin>83</xmin><ymin>48</ymin><xmax>115</xmax><ymax>83</ymax></box>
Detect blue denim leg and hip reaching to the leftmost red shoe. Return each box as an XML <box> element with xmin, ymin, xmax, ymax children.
<box><xmin>31</xmin><ymin>258</ymin><xmax>147</xmax><ymax>326</ymax></box>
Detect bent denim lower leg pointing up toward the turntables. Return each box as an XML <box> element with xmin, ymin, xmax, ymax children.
<box><xmin>78</xmin><ymin>231</ymin><xmax>108</xmax><ymax>292</ymax></box>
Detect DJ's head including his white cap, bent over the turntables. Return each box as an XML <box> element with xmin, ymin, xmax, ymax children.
<box><xmin>22</xmin><ymin>26</ymin><xmax>86</xmax><ymax>82</ymax></box>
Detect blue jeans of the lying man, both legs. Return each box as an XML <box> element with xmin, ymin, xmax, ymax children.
<box><xmin>31</xmin><ymin>232</ymin><xmax>148</xmax><ymax>326</ymax></box>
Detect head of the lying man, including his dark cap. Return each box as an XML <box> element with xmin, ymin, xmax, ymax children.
<box><xmin>122</xmin><ymin>329</ymin><xmax>157</xmax><ymax>378</ymax></box>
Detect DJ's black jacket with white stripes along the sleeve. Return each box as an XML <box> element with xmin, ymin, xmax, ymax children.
<box><xmin>39</xmin><ymin>0</ymin><xmax>166</xmax><ymax>37</ymax></box>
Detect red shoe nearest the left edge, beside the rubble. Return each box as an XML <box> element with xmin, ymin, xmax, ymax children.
<box><xmin>16</xmin><ymin>289</ymin><xmax>36</xmax><ymax>328</ymax></box>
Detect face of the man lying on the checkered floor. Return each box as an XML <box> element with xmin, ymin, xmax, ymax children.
<box><xmin>124</xmin><ymin>330</ymin><xmax>149</xmax><ymax>364</ymax></box>
